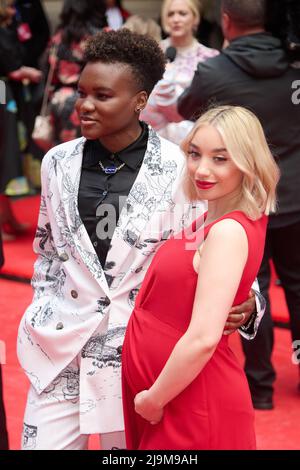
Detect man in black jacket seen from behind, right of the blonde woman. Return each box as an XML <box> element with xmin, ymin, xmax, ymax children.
<box><xmin>178</xmin><ymin>0</ymin><xmax>300</xmax><ymax>410</ymax></box>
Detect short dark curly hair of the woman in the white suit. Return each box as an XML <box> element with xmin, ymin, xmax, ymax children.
<box><xmin>84</xmin><ymin>28</ymin><xmax>166</xmax><ymax>95</ymax></box>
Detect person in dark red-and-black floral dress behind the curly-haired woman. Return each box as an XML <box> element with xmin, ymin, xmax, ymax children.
<box><xmin>49</xmin><ymin>0</ymin><xmax>107</xmax><ymax>145</ymax></box>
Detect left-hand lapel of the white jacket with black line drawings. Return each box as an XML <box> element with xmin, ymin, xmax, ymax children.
<box><xmin>54</xmin><ymin>138</ymin><xmax>109</xmax><ymax>295</ymax></box>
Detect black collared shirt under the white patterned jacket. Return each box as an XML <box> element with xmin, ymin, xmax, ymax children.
<box><xmin>78</xmin><ymin>122</ymin><xmax>148</xmax><ymax>267</ymax></box>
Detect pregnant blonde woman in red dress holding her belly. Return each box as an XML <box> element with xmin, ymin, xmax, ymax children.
<box><xmin>123</xmin><ymin>106</ymin><xmax>279</xmax><ymax>449</ymax></box>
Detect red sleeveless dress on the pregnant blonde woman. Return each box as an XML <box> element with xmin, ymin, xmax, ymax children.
<box><xmin>122</xmin><ymin>211</ymin><xmax>267</xmax><ymax>449</ymax></box>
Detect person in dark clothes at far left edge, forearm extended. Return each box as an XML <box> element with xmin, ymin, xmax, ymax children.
<box><xmin>0</xmin><ymin>0</ymin><xmax>42</xmax><ymax>240</ymax></box>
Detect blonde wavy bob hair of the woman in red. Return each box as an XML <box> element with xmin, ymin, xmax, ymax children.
<box><xmin>181</xmin><ymin>106</ymin><xmax>279</xmax><ymax>220</ymax></box>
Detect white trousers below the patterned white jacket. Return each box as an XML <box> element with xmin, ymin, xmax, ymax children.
<box><xmin>21</xmin><ymin>358</ymin><xmax>126</xmax><ymax>450</ymax></box>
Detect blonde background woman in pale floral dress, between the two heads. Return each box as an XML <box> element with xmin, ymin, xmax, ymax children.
<box><xmin>141</xmin><ymin>0</ymin><xmax>219</xmax><ymax>143</ymax></box>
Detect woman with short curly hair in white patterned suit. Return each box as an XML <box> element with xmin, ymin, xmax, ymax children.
<box><xmin>18</xmin><ymin>29</ymin><xmax>260</xmax><ymax>450</ymax></box>
